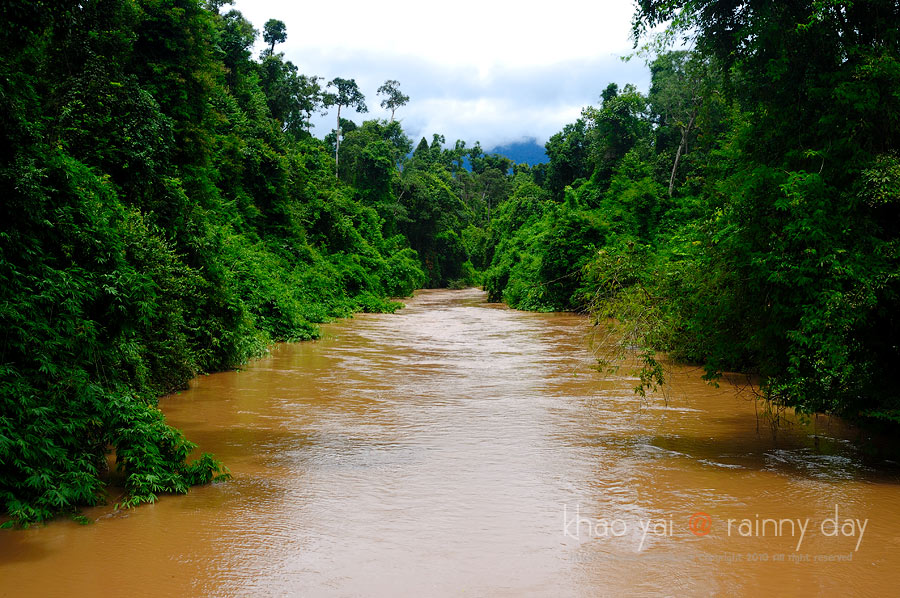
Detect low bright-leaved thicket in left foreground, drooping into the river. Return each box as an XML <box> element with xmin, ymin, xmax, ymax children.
<box><xmin>0</xmin><ymin>151</ymin><xmax>232</xmax><ymax>523</ymax></box>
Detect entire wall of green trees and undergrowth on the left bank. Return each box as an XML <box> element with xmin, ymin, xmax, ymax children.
<box><xmin>0</xmin><ymin>0</ymin><xmax>424</xmax><ymax>524</ymax></box>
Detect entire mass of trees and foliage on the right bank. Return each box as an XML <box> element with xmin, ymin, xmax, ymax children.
<box><xmin>485</xmin><ymin>0</ymin><xmax>900</xmax><ymax>432</ymax></box>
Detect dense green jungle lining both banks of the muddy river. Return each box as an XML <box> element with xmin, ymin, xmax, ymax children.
<box><xmin>0</xmin><ymin>0</ymin><xmax>900</xmax><ymax>523</ymax></box>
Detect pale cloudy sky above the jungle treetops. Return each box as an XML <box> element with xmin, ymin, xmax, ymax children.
<box><xmin>224</xmin><ymin>0</ymin><xmax>649</xmax><ymax>148</ymax></box>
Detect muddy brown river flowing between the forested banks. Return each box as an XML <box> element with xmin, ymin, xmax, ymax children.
<box><xmin>0</xmin><ymin>289</ymin><xmax>900</xmax><ymax>597</ymax></box>
